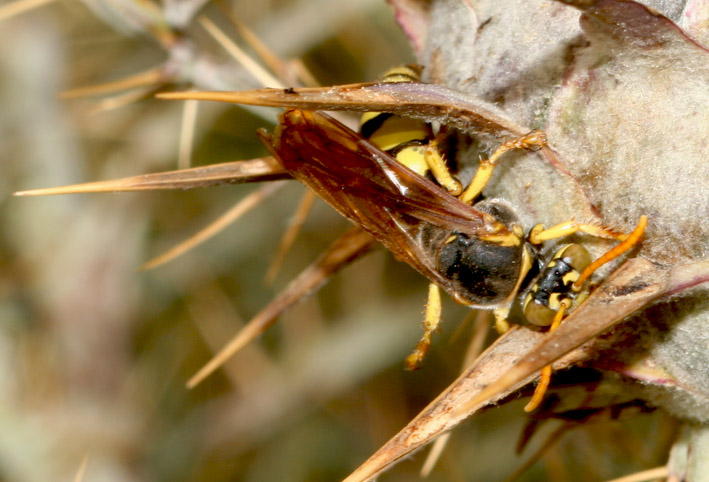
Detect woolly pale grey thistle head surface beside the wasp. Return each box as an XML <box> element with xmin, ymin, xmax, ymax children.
<box><xmin>404</xmin><ymin>0</ymin><xmax>709</xmax><ymax>422</ymax></box>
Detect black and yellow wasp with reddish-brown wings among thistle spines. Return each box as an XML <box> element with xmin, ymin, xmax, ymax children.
<box><xmin>260</xmin><ymin>70</ymin><xmax>644</xmax><ymax>392</ymax></box>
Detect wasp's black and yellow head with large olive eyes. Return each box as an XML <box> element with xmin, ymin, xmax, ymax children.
<box><xmin>524</xmin><ymin>244</ymin><xmax>591</xmax><ymax>326</ymax></box>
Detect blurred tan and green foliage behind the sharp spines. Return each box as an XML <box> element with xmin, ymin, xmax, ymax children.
<box><xmin>0</xmin><ymin>0</ymin><xmax>674</xmax><ymax>481</ymax></box>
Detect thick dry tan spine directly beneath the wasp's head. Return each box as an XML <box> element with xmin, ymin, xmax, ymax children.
<box><xmin>346</xmin><ymin>258</ymin><xmax>709</xmax><ymax>482</ymax></box>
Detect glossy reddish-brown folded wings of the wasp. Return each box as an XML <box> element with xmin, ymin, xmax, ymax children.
<box><xmin>266</xmin><ymin>110</ymin><xmax>505</xmax><ymax>283</ymax></box>
